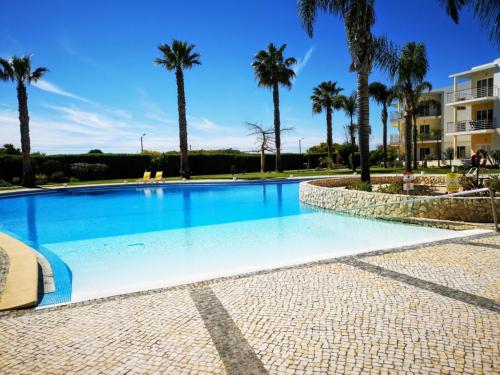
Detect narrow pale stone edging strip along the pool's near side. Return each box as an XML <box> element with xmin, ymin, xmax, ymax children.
<box><xmin>0</xmin><ymin>232</ymin><xmax>499</xmax><ymax>318</ymax></box>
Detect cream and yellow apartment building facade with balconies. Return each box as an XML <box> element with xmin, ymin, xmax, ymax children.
<box><xmin>390</xmin><ymin>58</ymin><xmax>500</xmax><ymax>164</ymax></box>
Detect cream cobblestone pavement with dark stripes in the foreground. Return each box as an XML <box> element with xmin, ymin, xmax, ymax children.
<box><xmin>0</xmin><ymin>236</ymin><xmax>500</xmax><ymax>374</ymax></box>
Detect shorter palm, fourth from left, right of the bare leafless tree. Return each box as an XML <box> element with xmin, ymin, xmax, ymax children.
<box><xmin>311</xmin><ymin>81</ymin><xmax>343</xmax><ymax>160</ymax></box>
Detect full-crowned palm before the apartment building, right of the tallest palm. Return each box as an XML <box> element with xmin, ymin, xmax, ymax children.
<box><xmin>380</xmin><ymin>42</ymin><xmax>431</xmax><ymax>172</ymax></box>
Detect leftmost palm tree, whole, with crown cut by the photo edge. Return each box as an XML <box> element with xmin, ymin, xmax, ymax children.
<box><xmin>0</xmin><ymin>55</ymin><xmax>49</xmax><ymax>187</ymax></box>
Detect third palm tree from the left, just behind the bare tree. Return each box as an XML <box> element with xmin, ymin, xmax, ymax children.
<box><xmin>252</xmin><ymin>43</ymin><xmax>297</xmax><ymax>172</ymax></box>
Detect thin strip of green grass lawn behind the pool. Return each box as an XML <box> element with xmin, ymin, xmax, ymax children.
<box><xmin>0</xmin><ymin>167</ymin><xmax>500</xmax><ymax>192</ymax></box>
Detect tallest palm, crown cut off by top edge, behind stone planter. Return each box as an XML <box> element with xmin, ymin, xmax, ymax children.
<box><xmin>297</xmin><ymin>0</ymin><xmax>377</xmax><ymax>182</ymax></box>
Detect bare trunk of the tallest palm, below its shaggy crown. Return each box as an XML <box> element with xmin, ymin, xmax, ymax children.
<box><xmin>357</xmin><ymin>72</ymin><xmax>370</xmax><ymax>182</ymax></box>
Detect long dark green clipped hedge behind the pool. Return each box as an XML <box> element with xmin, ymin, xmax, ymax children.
<box><xmin>0</xmin><ymin>153</ymin><xmax>325</xmax><ymax>181</ymax></box>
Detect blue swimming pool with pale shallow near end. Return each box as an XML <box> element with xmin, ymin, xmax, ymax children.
<box><xmin>0</xmin><ymin>181</ymin><xmax>476</xmax><ymax>305</ymax></box>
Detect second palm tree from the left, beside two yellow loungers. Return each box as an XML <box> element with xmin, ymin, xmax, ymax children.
<box><xmin>155</xmin><ymin>40</ymin><xmax>201</xmax><ymax>179</ymax></box>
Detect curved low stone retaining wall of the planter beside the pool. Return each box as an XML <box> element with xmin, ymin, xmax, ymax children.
<box><xmin>300</xmin><ymin>175</ymin><xmax>500</xmax><ymax>223</ymax></box>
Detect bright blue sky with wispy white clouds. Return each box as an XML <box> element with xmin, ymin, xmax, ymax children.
<box><xmin>0</xmin><ymin>0</ymin><xmax>500</xmax><ymax>153</ymax></box>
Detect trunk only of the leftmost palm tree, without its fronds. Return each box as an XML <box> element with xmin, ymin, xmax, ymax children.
<box><xmin>17</xmin><ymin>82</ymin><xmax>35</xmax><ymax>187</ymax></box>
